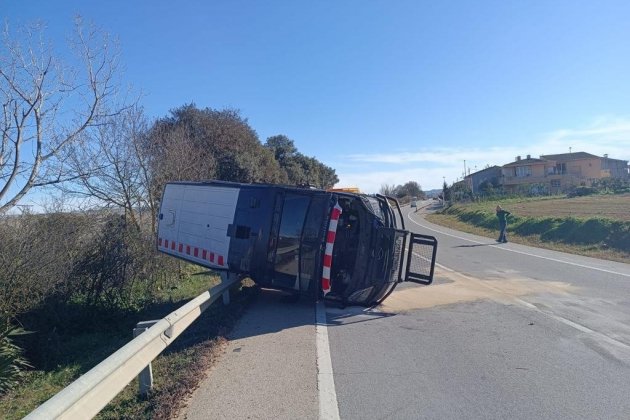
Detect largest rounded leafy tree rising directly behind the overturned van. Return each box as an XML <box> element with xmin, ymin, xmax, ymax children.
<box><xmin>148</xmin><ymin>104</ymin><xmax>284</xmax><ymax>193</ymax></box>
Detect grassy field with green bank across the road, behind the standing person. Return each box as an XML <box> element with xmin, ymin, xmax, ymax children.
<box><xmin>427</xmin><ymin>194</ymin><xmax>630</xmax><ymax>263</ymax></box>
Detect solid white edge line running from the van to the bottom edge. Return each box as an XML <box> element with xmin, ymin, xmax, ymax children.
<box><xmin>315</xmin><ymin>301</ymin><xmax>339</xmax><ymax>420</ymax></box>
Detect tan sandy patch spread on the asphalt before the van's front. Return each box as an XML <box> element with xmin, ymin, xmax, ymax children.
<box><xmin>378</xmin><ymin>269</ymin><xmax>574</xmax><ymax>312</ymax></box>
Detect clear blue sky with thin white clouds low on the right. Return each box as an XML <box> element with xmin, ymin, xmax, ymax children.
<box><xmin>0</xmin><ymin>0</ymin><xmax>630</xmax><ymax>192</ymax></box>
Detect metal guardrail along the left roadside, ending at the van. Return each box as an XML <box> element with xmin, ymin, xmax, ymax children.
<box><xmin>25</xmin><ymin>275</ymin><xmax>239</xmax><ymax>420</ymax></box>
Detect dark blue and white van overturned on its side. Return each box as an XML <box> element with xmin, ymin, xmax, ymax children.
<box><xmin>157</xmin><ymin>181</ymin><xmax>437</xmax><ymax>306</ymax></box>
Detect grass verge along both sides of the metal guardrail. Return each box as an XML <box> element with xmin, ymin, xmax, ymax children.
<box><xmin>0</xmin><ymin>268</ymin><xmax>256</xmax><ymax>419</ymax></box>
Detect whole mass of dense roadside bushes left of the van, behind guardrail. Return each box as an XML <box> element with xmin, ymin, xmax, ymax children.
<box><xmin>0</xmin><ymin>212</ymin><xmax>179</xmax><ymax>374</ymax></box>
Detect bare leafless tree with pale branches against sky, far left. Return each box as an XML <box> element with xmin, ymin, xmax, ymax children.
<box><xmin>0</xmin><ymin>17</ymin><xmax>126</xmax><ymax>214</ymax></box>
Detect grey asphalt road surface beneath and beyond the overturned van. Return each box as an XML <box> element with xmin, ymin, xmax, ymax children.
<box><xmin>182</xmin><ymin>202</ymin><xmax>630</xmax><ymax>419</ymax></box>
